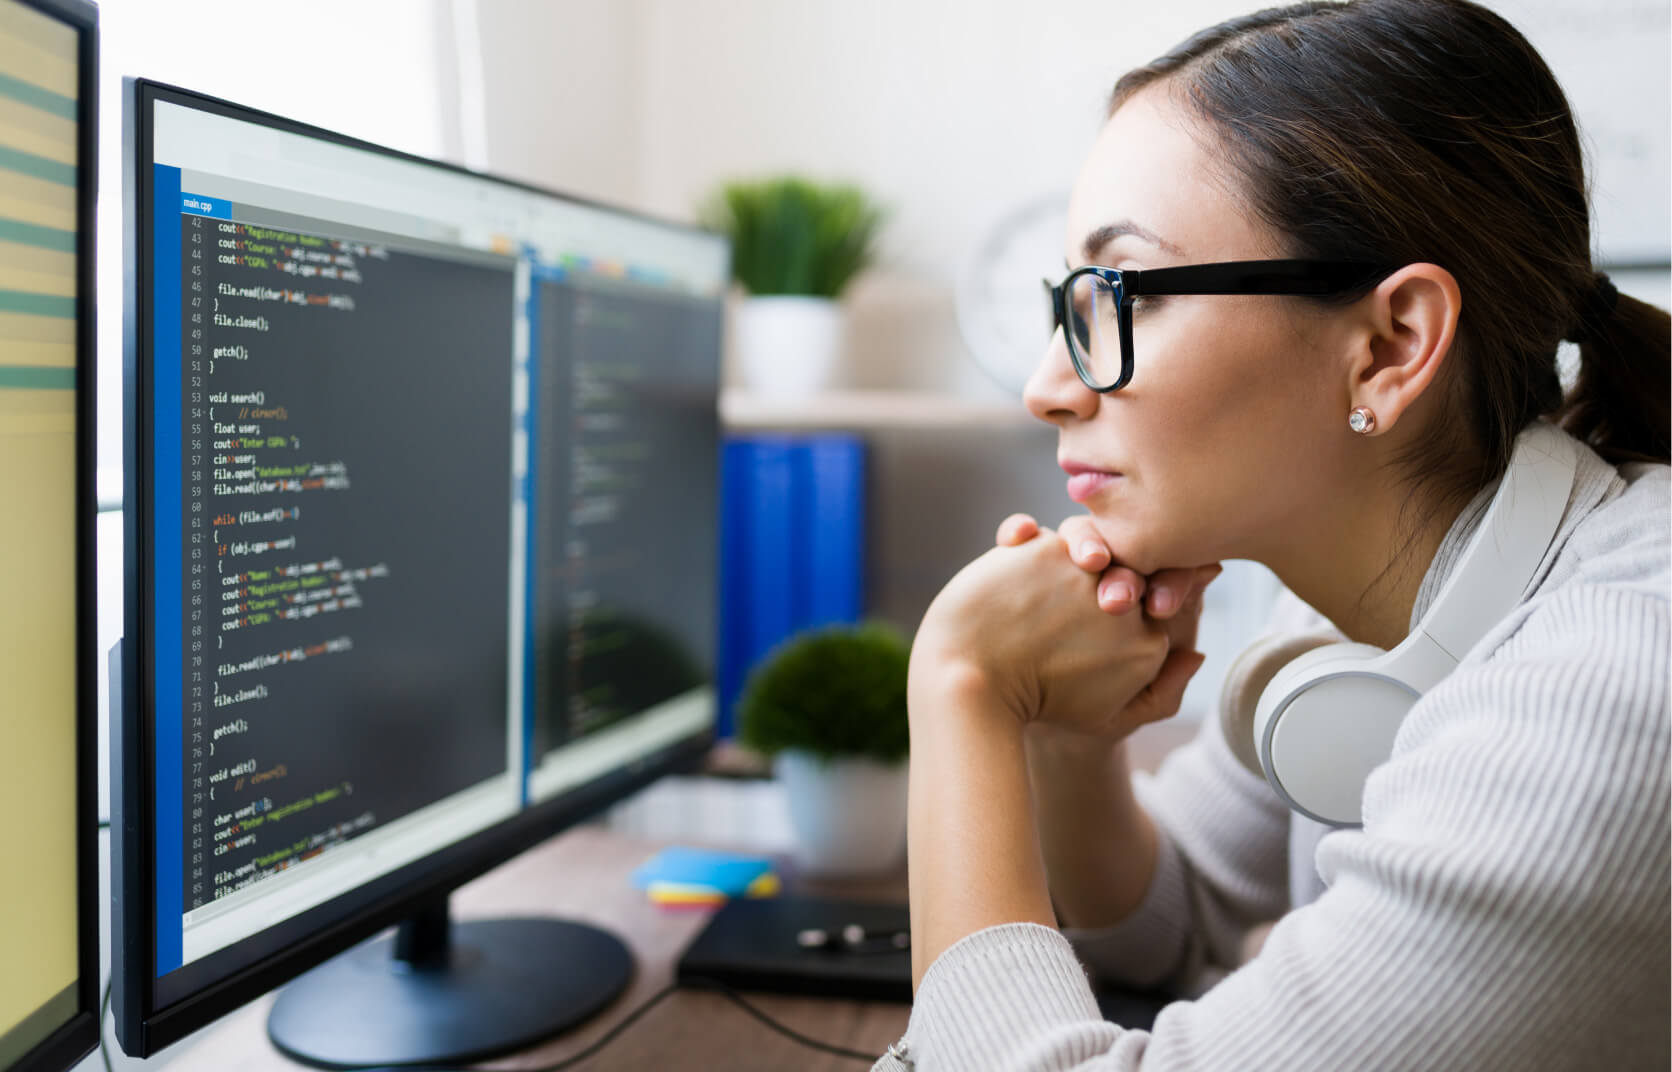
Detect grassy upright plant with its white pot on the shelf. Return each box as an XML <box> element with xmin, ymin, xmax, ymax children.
<box><xmin>699</xmin><ymin>176</ymin><xmax>883</xmax><ymax>398</ymax></box>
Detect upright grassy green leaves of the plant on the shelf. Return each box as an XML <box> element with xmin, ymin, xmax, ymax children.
<box><xmin>699</xmin><ymin>176</ymin><xmax>884</xmax><ymax>298</ymax></box>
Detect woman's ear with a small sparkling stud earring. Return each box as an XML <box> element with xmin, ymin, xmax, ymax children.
<box><xmin>1348</xmin><ymin>264</ymin><xmax>1463</xmax><ymax>431</ymax></box>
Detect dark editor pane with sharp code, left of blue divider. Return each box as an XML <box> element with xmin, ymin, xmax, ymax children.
<box><xmin>173</xmin><ymin>212</ymin><xmax>515</xmax><ymax>911</ymax></box>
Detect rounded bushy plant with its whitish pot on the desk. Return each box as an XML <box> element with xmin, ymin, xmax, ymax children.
<box><xmin>737</xmin><ymin>624</ymin><xmax>911</xmax><ymax>875</ymax></box>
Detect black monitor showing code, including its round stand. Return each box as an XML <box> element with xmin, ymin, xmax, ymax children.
<box><xmin>115</xmin><ymin>82</ymin><xmax>729</xmax><ymax>1065</ymax></box>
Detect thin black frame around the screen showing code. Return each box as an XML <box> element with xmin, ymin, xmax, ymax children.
<box><xmin>112</xmin><ymin>79</ymin><xmax>718</xmax><ymax>1057</ymax></box>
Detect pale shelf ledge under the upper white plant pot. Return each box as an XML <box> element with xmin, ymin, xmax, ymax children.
<box><xmin>721</xmin><ymin>388</ymin><xmax>1043</xmax><ymax>431</ymax></box>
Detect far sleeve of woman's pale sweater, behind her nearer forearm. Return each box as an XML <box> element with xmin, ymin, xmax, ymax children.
<box><xmin>1063</xmin><ymin>592</ymin><xmax>1328</xmax><ymax>993</ymax></box>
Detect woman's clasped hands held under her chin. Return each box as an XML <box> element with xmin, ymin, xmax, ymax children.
<box><xmin>911</xmin><ymin>513</ymin><xmax>1221</xmax><ymax>739</ymax></box>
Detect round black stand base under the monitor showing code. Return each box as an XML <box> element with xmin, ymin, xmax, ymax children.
<box><xmin>268</xmin><ymin>898</ymin><xmax>634</xmax><ymax>1069</ymax></box>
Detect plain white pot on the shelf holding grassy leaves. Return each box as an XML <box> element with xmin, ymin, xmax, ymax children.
<box><xmin>732</xmin><ymin>294</ymin><xmax>843</xmax><ymax>398</ymax></box>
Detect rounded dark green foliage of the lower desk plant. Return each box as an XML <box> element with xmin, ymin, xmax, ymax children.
<box><xmin>737</xmin><ymin>624</ymin><xmax>911</xmax><ymax>763</ymax></box>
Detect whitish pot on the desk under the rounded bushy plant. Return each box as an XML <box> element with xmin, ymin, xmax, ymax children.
<box><xmin>777</xmin><ymin>751</ymin><xmax>906</xmax><ymax>876</ymax></box>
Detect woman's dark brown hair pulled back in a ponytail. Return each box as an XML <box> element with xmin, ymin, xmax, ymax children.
<box><xmin>1109</xmin><ymin>0</ymin><xmax>1672</xmax><ymax>498</ymax></box>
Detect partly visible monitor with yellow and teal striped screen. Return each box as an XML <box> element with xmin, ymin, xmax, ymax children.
<box><xmin>0</xmin><ymin>0</ymin><xmax>99</xmax><ymax>1072</ymax></box>
